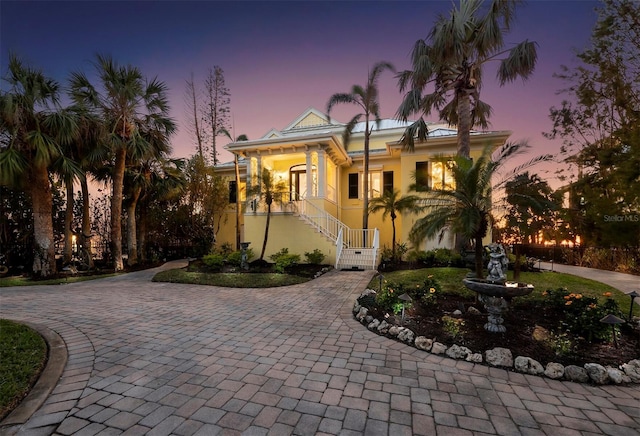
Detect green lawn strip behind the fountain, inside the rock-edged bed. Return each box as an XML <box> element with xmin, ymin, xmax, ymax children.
<box><xmin>368</xmin><ymin>268</ymin><xmax>640</xmax><ymax>316</ymax></box>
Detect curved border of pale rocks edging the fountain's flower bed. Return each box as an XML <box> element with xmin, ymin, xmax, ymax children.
<box><xmin>352</xmin><ymin>289</ymin><xmax>640</xmax><ymax>385</ymax></box>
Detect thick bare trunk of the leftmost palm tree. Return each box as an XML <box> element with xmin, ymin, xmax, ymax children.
<box><xmin>29</xmin><ymin>165</ymin><xmax>57</xmax><ymax>278</ymax></box>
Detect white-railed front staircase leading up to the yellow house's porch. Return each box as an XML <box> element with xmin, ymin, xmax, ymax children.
<box><xmin>294</xmin><ymin>199</ymin><xmax>380</xmax><ymax>270</ymax></box>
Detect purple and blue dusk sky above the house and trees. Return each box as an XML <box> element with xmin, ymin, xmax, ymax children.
<box><xmin>0</xmin><ymin>0</ymin><xmax>599</xmax><ymax>185</ymax></box>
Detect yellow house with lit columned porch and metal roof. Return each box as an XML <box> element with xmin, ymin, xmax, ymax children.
<box><xmin>216</xmin><ymin>108</ymin><xmax>511</xmax><ymax>269</ymax></box>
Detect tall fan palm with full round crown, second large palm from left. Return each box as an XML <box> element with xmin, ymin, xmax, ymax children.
<box><xmin>71</xmin><ymin>55</ymin><xmax>175</xmax><ymax>271</ymax></box>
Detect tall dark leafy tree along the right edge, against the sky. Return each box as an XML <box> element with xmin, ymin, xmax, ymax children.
<box><xmin>547</xmin><ymin>0</ymin><xmax>640</xmax><ymax>247</ymax></box>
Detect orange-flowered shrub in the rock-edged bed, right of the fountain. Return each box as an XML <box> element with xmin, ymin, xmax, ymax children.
<box><xmin>543</xmin><ymin>288</ymin><xmax>622</xmax><ymax>342</ymax></box>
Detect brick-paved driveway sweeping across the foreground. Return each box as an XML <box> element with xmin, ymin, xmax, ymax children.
<box><xmin>0</xmin><ymin>260</ymin><xmax>640</xmax><ymax>436</ymax></box>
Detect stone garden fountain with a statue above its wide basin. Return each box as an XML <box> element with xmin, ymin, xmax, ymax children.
<box><xmin>463</xmin><ymin>243</ymin><xmax>533</xmax><ymax>333</ymax></box>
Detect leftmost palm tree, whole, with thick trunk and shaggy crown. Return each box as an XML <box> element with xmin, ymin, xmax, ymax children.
<box><xmin>0</xmin><ymin>55</ymin><xmax>76</xmax><ymax>277</ymax></box>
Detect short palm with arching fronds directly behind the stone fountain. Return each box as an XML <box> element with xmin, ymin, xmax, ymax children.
<box><xmin>409</xmin><ymin>143</ymin><xmax>528</xmax><ymax>277</ymax></box>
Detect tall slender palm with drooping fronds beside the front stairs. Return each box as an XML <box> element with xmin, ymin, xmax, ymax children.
<box><xmin>327</xmin><ymin>62</ymin><xmax>395</xmax><ymax>229</ymax></box>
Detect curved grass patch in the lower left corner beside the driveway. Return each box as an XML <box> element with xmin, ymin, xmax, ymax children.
<box><xmin>0</xmin><ymin>319</ymin><xmax>47</xmax><ymax>419</ymax></box>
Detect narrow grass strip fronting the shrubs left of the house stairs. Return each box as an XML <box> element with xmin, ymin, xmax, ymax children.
<box><xmin>153</xmin><ymin>269</ymin><xmax>309</xmax><ymax>288</ymax></box>
